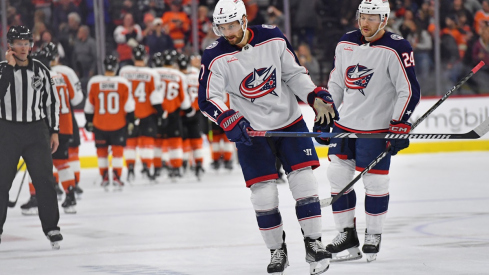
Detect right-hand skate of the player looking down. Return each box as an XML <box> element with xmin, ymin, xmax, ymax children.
<box><xmin>304</xmin><ymin>237</ymin><xmax>331</xmax><ymax>275</ymax></box>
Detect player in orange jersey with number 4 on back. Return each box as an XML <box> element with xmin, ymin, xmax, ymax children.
<box><xmin>119</xmin><ymin>45</ymin><xmax>163</xmax><ymax>180</ymax></box>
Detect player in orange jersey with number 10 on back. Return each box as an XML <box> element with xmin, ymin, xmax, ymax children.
<box><xmin>85</xmin><ymin>55</ymin><xmax>135</xmax><ymax>190</ymax></box>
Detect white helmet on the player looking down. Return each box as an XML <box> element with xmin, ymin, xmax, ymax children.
<box><xmin>212</xmin><ymin>0</ymin><xmax>247</xmax><ymax>36</ymax></box>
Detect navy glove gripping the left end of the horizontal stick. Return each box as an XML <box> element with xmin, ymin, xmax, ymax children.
<box><xmin>217</xmin><ymin>109</ymin><xmax>253</xmax><ymax>146</ymax></box>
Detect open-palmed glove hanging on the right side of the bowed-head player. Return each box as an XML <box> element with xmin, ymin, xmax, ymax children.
<box><xmin>307</xmin><ymin>87</ymin><xmax>340</xmax><ymax>126</ymax></box>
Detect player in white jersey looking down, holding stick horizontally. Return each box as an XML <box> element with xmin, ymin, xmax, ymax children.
<box><xmin>199</xmin><ymin>0</ymin><xmax>337</xmax><ymax>274</ymax></box>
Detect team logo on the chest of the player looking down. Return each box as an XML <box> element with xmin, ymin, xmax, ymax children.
<box><xmin>239</xmin><ymin>65</ymin><xmax>278</xmax><ymax>102</ymax></box>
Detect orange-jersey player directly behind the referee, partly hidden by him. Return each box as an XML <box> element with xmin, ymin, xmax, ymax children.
<box><xmin>21</xmin><ymin>45</ymin><xmax>76</xmax><ymax>215</ymax></box>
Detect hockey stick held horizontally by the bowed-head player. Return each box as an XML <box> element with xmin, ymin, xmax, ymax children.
<box><xmin>248</xmin><ymin>118</ymin><xmax>489</xmax><ymax>139</ymax></box>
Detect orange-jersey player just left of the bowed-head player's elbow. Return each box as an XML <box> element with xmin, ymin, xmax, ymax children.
<box><xmin>177</xmin><ymin>54</ymin><xmax>207</xmax><ymax>180</ymax></box>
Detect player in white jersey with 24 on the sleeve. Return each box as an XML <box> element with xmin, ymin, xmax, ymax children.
<box><xmin>320</xmin><ymin>0</ymin><xmax>420</xmax><ymax>262</ymax></box>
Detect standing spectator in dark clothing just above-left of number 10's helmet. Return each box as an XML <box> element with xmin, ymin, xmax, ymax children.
<box><xmin>72</xmin><ymin>25</ymin><xmax>97</xmax><ymax>91</ymax></box>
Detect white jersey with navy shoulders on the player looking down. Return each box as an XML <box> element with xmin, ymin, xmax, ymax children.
<box><xmin>199</xmin><ymin>25</ymin><xmax>316</xmax><ymax>130</ymax></box>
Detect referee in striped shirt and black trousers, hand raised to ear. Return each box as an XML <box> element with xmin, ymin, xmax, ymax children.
<box><xmin>0</xmin><ymin>26</ymin><xmax>63</xmax><ymax>248</ymax></box>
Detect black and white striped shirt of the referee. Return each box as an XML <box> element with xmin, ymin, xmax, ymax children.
<box><xmin>0</xmin><ymin>57</ymin><xmax>60</xmax><ymax>133</ymax></box>
